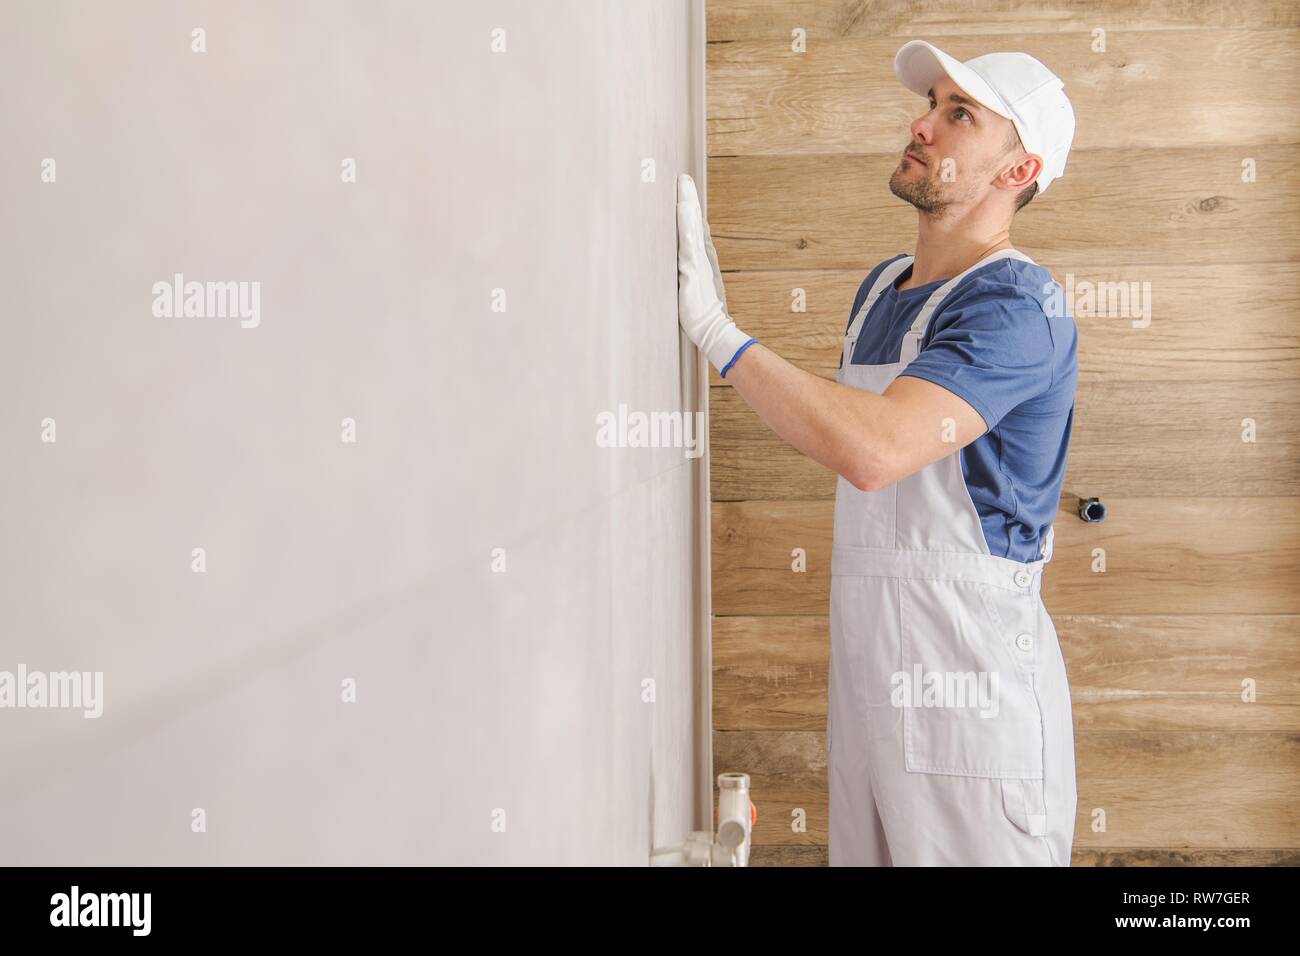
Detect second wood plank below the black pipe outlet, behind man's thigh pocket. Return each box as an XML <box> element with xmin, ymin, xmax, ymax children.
<box><xmin>712</xmin><ymin>614</ymin><xmax>1300</xmax><ymax>732</ymax></box>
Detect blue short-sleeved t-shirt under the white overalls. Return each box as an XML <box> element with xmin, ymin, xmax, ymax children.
<box><xmin>841</xmin><ymin>254</ymin><xmax>1079</xmax><ymax>562</ymax></box>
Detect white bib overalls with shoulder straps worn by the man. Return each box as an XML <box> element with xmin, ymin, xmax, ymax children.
<box><xmin>827</xmin><ymin>248</ymin><xmax>1076</xmax><ymax>866</ymax></box>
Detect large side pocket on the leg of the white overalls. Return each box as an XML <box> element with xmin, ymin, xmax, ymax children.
<box><xmin>893</xmin><ymin>579</ymin><xmax>1043</xmax><ymax>785</ymax></box>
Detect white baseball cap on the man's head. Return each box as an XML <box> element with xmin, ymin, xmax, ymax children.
<box><xmin>894</xmin><ymin>40</ymin><xmax>1074</xmax><ymax>193</ymax></box>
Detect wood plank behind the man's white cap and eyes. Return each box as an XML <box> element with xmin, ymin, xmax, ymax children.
<box><xmin>709</xmin><ymin>25</ymin><xmax>1300</xmax><ymax>155</ymax></box>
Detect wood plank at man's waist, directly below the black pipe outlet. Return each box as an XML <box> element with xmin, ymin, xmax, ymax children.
<box><xmin>712</xmin><ymin>497</ymin><xmax>1300</xmax><ymax>615</ymax></box>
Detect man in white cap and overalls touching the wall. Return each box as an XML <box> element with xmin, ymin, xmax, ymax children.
<box><xmin>677</xmin><ymin>40</ymin><xmax>1078</xmax><ymax>866</ymax></box>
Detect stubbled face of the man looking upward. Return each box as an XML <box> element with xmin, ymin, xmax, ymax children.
<box><xmin>889</xmin><ymin>75</ymin><xmax>1024</xmax><ymax>215</ymax></box>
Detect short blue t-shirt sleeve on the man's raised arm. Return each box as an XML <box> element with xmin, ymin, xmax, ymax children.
<box><xmin>901</xmin><ymin>287</ymin><xmax>1053</xmax><ymax>429</ymax></box>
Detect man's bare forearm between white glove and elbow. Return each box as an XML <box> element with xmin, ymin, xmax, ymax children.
<box><xmin>727</xmin><ymin>342</ymin><xmax>888</xmax><ymax>490</ymax></box>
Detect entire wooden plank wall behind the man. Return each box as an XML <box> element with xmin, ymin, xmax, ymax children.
<box><xmin>709</xmin><ymin>0</ymin><xmax>1300</xmax><ymax>865</ymax></box>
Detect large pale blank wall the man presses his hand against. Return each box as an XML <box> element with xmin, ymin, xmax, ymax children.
<box><xmin>0</xmin><ymin>0</ymin><xmax>709</xmax><ymax>865</ymax></box>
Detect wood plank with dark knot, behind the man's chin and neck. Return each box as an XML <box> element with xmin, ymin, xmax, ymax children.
<box><xmin>709</xmin><ymin>140</ymin><xmax>1300</xmax><ymax>273</ymax></box>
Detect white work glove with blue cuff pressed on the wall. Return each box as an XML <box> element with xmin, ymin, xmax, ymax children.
<box><xmin>677</xmin><ymin>173</ymin><xmax>750</xmax><ymax>372</ymax></box>
